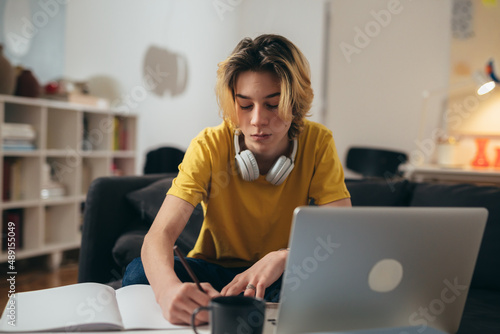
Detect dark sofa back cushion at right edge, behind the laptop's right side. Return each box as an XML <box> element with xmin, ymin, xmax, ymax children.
<box><xmin>410</xmin><ymin>183</ymin><xmax>500</xmax><ymax>290</ymax></box>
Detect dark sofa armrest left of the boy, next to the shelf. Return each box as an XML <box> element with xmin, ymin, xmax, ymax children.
<box><xmin>78</xmin><ymin>174</ymin><xmax>176</xmax><ymax>283</ymax></box>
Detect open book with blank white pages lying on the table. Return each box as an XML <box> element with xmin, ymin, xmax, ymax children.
<box><xmin>0</xmin><ymin>283</ymin><xmax>189</xmax><ymax>332</ymax></box>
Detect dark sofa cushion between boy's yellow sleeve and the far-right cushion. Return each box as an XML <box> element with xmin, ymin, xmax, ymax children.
<box><xmin>346</xmin><ymin>179</ymin><xmax>412</xmax><ymax>206</ymax></box>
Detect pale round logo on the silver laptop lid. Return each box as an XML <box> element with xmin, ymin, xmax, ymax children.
<box><xmin>368</xmin><ymin>259</ymin><xmax>403</xmax><ymax>293</ymax></box>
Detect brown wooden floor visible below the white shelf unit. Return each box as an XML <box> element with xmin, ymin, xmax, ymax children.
<box><xmin>0</xmin><ymin>250</ymin><xmax>78</xmax><ymax>311</ymax></box>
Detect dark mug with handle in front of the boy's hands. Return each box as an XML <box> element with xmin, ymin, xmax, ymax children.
<box><xmin>191</xmin><ymin>296</ymin><xmax>266</xmax><ymax>334</ymax></box>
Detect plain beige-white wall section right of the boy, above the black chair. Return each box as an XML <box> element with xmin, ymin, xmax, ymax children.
<box><xmin>326</xmin><ymin>0</ymin><xmax>451</xmax><ymax>176</ymax></box>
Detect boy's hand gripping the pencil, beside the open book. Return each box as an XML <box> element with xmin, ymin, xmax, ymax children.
<box><xmin>158</xmin><ymin>282</ymin><xmax>221</xmax><ymax>325</ymax></box>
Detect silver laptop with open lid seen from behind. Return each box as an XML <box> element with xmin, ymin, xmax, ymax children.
<box><xmin>276</xmin><ymin>207</ymin><xmax>488</xmax><ymax>334</ymax></box>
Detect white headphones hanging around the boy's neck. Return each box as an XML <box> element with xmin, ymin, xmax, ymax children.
<box><xmin>234</xmin><ymin>130</ymin><xmax>297</xmax><ymax>186</ymax></box>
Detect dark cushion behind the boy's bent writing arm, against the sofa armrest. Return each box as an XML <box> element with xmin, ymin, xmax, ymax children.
<box><xmin>126</xmin><ymin>178</ymin><xmax>203</xmax><ymax>254</ymax></box>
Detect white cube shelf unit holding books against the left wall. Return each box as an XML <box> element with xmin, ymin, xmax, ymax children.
<box><xmin>0</xmin><ymin>95</ymin><xmax>137</xmax><ymax>263</ymax></box>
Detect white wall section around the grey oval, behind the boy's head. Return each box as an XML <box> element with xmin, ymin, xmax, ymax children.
<box><xmin>65</xmin><ymin>0</ymin><xmax>324</xmax><ymax>172</ymax></box>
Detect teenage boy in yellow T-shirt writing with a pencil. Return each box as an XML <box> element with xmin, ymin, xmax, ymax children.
<box><xmin>123</xmin><ymin>35</ymin><xmax>351</xmax><ymax>324</ymax></box>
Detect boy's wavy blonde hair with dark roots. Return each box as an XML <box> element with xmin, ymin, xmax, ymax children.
<box><xmin>215</xmin><ymin>34</ymin><xmax>314</xmax><ymax>139</ymax></box>
